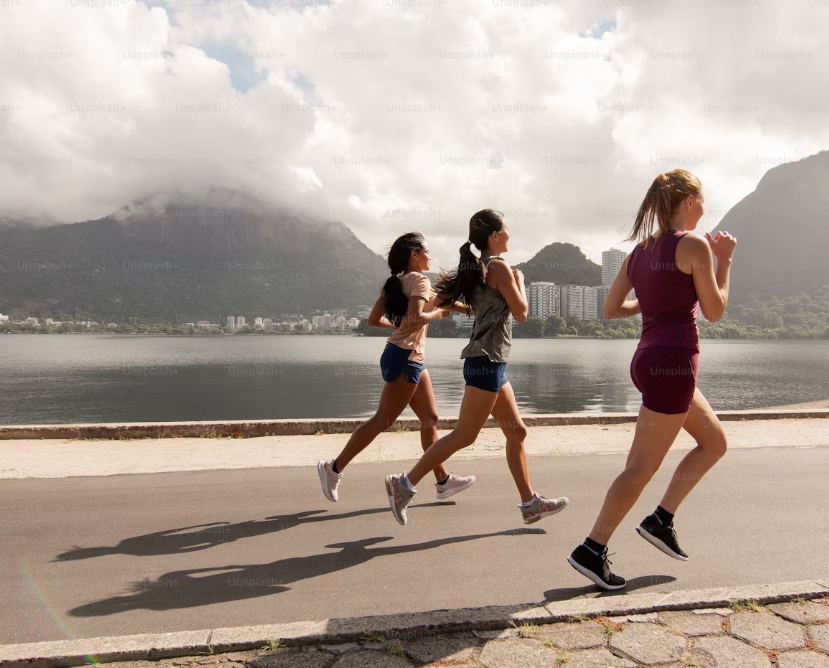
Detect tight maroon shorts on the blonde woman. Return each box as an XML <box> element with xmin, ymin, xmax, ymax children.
<box><xmin>630</xmin><ymin>346</ymin><xmax>699</xmax><ymax>415</ymax></box>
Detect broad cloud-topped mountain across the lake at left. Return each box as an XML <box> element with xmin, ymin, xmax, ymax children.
<box><xmin>0</xmin><ymin>191</ymin><xmax>388</xmax><ymax>322</ymax></box>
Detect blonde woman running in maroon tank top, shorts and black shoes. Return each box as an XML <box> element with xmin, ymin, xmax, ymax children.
<box><xmin>568</xmin><ymin>169</ymin><xmax>737</xmax><ymax>590</ymax></box>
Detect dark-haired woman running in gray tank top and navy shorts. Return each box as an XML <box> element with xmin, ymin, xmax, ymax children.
<box><xmin>386</xmin><ymin>209</ymin><xmax>567</xmax><ymax>524</ymax></box>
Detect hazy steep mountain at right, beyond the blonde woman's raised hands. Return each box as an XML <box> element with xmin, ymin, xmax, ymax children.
<box><xmin>712</xmin><ymin>151</ymin><xmax>829</xmax><ymax>300</ymax></box>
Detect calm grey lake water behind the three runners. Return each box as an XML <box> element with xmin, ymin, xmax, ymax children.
<box><xmin>0</xmin><ymin>334</ymin><xmax>829</xmax><ymax>425</ymax></box>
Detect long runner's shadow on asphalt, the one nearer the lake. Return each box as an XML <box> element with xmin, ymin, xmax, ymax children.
<box><xmin>55</xmin><ymin>501</ymin><xmax>455</xmax><ymax>561</ymax></box>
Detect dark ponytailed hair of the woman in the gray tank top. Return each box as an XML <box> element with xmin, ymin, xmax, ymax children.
<box><xmin>435</xmin><ymin>209</ymin><xmax>504</xmax><ymax>312</ymax></box>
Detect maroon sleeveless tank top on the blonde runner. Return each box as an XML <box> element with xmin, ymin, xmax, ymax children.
<box><xmin>628</xmin><ymin>230</ymin><xmax>699</xmax><ymax>350</ymax></box>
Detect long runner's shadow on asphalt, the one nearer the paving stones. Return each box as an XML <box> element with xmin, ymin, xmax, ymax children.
<box><xmin>69</xmin><ymin>528</ymin><xmax>546</xmax><ymax>617</ymax></box>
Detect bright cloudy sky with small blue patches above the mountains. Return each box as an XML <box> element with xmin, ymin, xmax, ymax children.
<box><xmin>0</xmin><ymin>0</ymin><xmax>829</xmax><ymax>266</ymax></box>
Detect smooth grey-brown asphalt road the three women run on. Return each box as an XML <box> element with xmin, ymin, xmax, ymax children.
<box><xmin>0</xmin><ymin>446</ymin><xmax>829</xmax><ymax>643</ymax></box>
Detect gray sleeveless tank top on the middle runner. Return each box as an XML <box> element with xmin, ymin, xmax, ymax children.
<box><xmin>461</xmin><ymin>255</ymin><xmax>512</xmax><ymax>364</ymax></box>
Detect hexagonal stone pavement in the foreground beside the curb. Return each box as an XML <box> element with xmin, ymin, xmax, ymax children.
<box><xmin>109</xmin><ymin>596</ymin><xmax>829</xmax><ymax>668</ymax></box>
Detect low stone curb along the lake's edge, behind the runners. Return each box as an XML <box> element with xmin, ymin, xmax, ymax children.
<box><xmin>0</xmin><ymin>409</ymin><xmax>829</xmax><ymax>440</ymax></box>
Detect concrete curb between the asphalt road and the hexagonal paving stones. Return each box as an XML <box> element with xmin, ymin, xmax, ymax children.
<box><xmin>0</xmin><ymin>577</ymin><xmax>829</xmax><ymax>668</ymax></box>
